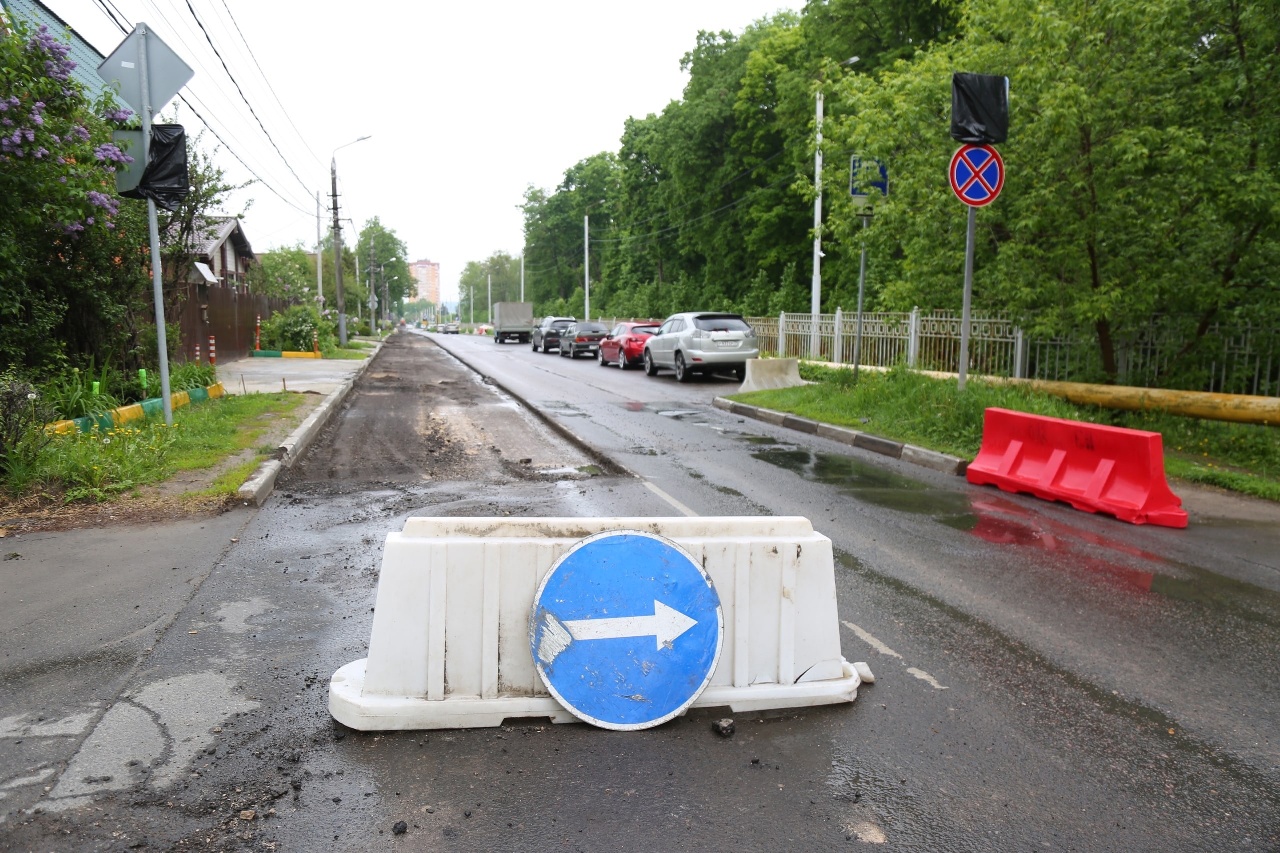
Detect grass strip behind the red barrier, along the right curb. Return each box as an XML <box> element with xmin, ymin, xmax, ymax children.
<box><xmin>733</xmin><ymin>364</ymin><xmax>1280</xmax><ymax>501</ymax></box>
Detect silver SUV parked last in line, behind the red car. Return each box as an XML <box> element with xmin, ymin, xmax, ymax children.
<box><xmin>644</xmin><ymin>311</ymin><xmax>760</xmax><ymax>382</ymax></box>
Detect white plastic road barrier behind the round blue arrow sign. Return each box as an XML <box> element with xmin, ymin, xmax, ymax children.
<box><xmin>329</xmin><ymin>516</ymin><xmax>865</xmax><ymax>731</ymax></box>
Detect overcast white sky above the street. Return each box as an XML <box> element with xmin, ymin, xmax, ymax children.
<box><xmin>44</xmin><ymin>0</ymin><xmax>804</xmax><ymax>300</ymax></box>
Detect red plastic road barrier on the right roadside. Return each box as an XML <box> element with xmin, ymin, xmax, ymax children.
<box><xmin>965</xmin><ymin>409</ymin><xmax>1187</xmax><ymax>528</ymax></box>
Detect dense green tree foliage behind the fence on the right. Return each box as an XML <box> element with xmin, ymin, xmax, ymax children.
<box><xmin>476</xmin><ymin>0</ymin><xmax>1280</xmax><ymax>378</ymax></box>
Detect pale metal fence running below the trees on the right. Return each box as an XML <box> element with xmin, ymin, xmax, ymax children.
<box><xmin>748</xmin><ymin>309</ymin><xmax>1280</xmax><ymax>397</ymax></box>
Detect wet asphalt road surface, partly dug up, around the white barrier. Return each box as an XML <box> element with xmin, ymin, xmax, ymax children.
<box><xmin>0</xmin><ymin>334</ymin><xmax>1280</xmax><ymax>850</ymax></box>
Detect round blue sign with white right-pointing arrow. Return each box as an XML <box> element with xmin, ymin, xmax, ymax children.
<box><xmin>529</xmin><ymin>530</ymin><xmax>724</xmax><ymax>731</ymax></box>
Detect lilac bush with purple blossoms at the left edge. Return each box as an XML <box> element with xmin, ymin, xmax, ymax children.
<box><xmin>0</xmin><ymin>19</ymin><xmax>146</xmax><ymax>371</ymax></box>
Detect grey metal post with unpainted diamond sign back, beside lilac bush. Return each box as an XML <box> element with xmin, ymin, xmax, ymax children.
<box><xmin>97</xmin><ymin>23</ymin><xmax>195</xmax><ymax>427</ymax></box>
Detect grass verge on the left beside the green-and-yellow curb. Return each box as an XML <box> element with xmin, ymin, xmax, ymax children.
<box><xmin>0</xmin><ymin>393</ymin><xmax>303</xmax><ymax>503</ymax></box>
